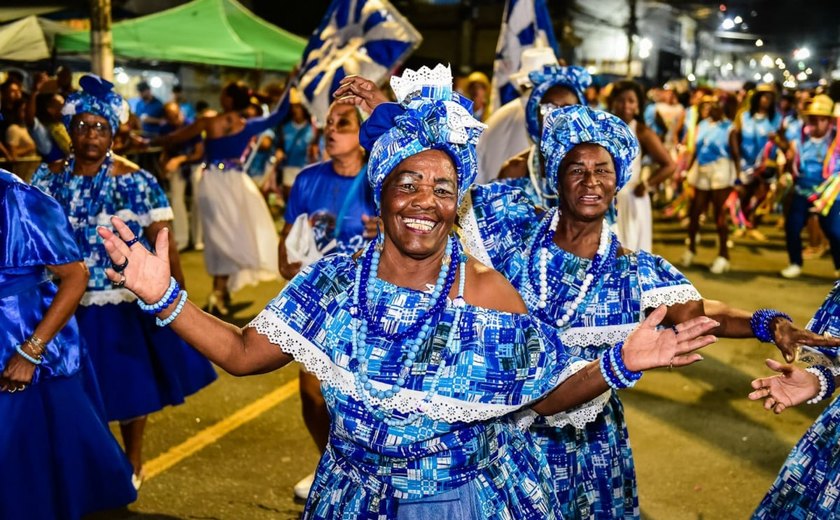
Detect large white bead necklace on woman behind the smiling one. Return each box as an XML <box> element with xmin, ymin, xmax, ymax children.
<box><xmin>525</xmin><ymin>209</ymin><xmax>618</xmax><ymax>329</ymax></box>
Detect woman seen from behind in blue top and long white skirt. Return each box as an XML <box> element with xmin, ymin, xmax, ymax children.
<box><xmin>152</xmin><ymin>82</ymin><xmax>288</xmax><ymax>316</ymax></box>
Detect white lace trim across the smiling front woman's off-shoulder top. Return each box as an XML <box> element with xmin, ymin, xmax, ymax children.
<box><xmin>248</xmin><ymin>310</ymin><xmax>522</xmax><ymax>423</ymax></box>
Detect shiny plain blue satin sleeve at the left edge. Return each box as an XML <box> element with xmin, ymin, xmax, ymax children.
<box><xmin>0</xmin><ymin>170</ymin><xmax>82</xmax><ymax>267</ymax></box>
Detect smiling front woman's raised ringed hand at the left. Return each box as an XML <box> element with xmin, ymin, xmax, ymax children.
<box><xmin>97</xmin><ymin>217</ymin><xmax>171</xmax><ymax>303</ymax></box>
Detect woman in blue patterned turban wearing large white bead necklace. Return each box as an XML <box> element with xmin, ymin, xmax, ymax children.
<box><xmin>460</xmin><ymin>106</ymin><xmax>836</xmax><ymax>518</ymax></box>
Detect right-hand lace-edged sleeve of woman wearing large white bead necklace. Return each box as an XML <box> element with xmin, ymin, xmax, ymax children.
<box><xmin>637</xmin><ymin>251</ymin><xmax>703</xmax><ymax>312</ymax></box>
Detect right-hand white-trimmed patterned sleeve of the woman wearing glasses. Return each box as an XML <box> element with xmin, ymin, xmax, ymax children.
<box><xmin>111</xmin><ymin>170</ymin><xmax>174</xmax><ymax>227</ymax></box>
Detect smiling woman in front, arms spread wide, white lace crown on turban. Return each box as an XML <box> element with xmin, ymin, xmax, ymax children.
<box><xmin>100</xmin><ymin>66</ymin><xmax>715</xmax><ymax>520</ymax></box>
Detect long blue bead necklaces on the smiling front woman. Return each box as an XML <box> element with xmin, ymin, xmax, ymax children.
<box><xmin>350</xmin><ymin>235</ymin><xmax>467</xmax><ymax>426</ymax></box>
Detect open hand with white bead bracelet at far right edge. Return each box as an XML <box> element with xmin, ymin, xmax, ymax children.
<box><xmin>749</xmin><ymin>359</ymin><xmax>820</xmax><ymax>413</ymax></box>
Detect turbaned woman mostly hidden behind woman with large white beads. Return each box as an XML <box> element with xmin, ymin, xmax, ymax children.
<box><xmin>499</xmin><ymin>65</ymin><xmax>592</xmax><ymax>208</ymax></box>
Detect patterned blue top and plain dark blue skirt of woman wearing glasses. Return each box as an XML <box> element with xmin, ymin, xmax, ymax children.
<box><xmin>32</xmin><ymin>159</ymin><xmax>216</xmax><ymax>421</ymax></box>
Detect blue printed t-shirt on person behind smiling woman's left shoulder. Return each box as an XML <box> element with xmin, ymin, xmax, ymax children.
<box><xmin>284</xmin><ymin>161</ymin><xmax>377</xmax><ymax>254</ymax></box>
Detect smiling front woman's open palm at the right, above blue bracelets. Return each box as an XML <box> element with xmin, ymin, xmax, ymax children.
<box><xmin>622</xmin><ymin>305</ymin><xmax>720</xmax><ymax>372</ymax></box>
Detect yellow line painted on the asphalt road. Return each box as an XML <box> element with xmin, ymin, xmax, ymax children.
<box><xmin>143</xmin><ymin>378</ymin><xmax>298</xmax><ymax>480</ymax></box>
